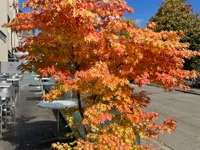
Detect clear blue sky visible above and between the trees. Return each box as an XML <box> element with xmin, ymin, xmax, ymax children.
<box><xmin>19</xmin><ymin>0</ymin><xmax>200</xmax><ymax>27</ymax></box>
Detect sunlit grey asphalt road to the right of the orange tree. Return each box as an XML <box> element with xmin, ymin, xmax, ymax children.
<box><xmin>134</xmin><ymin>86</ymin><xmax>200</xmax><ymax>150</ymax></box>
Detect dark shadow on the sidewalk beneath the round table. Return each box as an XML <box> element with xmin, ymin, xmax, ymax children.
<box><xmin>1</xmin><ymin>113</ymin><xmax>74</xmax><ymax>150</ymax></box>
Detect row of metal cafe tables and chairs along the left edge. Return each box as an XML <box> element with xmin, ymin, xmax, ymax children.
<box><xmin>0</xmin><ymin>73</ymin><xmax>22</xmax><ymax>137</ymax></box>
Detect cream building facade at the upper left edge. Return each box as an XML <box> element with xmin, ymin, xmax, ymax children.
<box><xmin>0</xmin><ymin>0</ymin><xmax>19</xmax><ymax>62</ymax></box>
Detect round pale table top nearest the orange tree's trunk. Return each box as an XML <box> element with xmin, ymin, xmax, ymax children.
<box><xmin>37</xmin><ymin>99</ymin><xmax>78</xmax><ymax>109</ymax></box>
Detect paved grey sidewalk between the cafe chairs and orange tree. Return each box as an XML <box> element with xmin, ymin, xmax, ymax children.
<box><xmin>0</xmin><ymin>75</ymin><xmax>69</xmax><ymax>150</ymax></box>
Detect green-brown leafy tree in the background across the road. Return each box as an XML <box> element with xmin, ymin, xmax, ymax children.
<box><xmin>150</xmin><ymin>0</ymin><xmax>200</xmax><ymax>71</ymax></box>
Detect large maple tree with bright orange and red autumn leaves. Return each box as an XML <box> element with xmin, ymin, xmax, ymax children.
<box><xmin>5</xmin><ymin>0</ymin><xmax>199</xmax><ymax>150</ymax></box>
